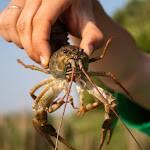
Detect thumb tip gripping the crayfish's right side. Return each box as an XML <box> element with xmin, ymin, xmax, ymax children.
<box><xmin>80</xmin><ymin>21</ymin><xmax>104</xmax><ymax>56</ymax></box>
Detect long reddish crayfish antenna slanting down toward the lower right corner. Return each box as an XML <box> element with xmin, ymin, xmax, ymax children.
<box><xmin>81</xmin><ymin>67</ymin><xmax>142</xmax><ymax>150</ymax></box>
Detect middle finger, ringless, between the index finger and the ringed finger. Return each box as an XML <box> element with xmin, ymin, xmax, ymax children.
<box><xmin>17</xmin><ymin>0</ymin><xmax>42</xmax><ymax>63</ymax></box>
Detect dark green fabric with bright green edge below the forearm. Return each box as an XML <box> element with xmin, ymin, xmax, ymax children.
<box><xmin>115</xmin><ymin>92</ymin><xmax>150</xmax><ymax>136</ymax></box>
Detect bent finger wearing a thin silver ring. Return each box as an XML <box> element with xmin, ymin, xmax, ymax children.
<box><xmin>2</xmin><ymin>0</ymin><xmax>24</xmax><ymax>48</ymax></box>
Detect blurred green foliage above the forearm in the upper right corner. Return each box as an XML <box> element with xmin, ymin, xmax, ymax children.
<box><xmin>113</xmin><ymin>0</ymin><xmax>150</xmax><ymax>52</ymax></box>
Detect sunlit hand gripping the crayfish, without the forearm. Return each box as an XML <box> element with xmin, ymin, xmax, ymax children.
<box><xmin>0</xmin><ymin>0</ymin><xmax>103</xmax><ymax>68</ymax></box>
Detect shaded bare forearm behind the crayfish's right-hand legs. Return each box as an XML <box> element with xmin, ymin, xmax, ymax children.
<box><xmin>70</xmin><ymin>0</ymin><xmax>150</xmax><ymax>109</ymax></box>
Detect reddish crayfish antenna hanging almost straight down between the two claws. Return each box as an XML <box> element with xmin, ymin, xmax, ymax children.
<box><xmin>55</xmin><ymin>67</ymin><xmax>75</xmax><ymax>150</ymax></box>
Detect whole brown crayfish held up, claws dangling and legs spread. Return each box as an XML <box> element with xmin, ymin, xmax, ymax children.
<box><xmin>18</xmin><ymin>20</ymin><xmax>142</xmax><ymax>150</ymax></box>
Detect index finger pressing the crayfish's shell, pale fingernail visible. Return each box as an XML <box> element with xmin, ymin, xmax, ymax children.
<box><xmin>32</xmin><ymin>0</ymin><xmax>69</xmax><ymax>66</ymax></box>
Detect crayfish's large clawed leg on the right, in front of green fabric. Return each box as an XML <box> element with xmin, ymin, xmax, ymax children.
<box><xmin>76</xmin><ymin>79</ymin><xmax>118</xmax><ymax>150</ymax></box>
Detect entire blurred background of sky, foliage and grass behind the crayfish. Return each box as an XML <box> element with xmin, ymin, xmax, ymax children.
<box><xmin>0</xmin><ymin>0</ymin><xmax>150</xmax><ymax>150</ymax></box>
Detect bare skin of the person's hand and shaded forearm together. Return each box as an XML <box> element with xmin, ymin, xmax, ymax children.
<box><xmin>0</xmin><ymin>0</ymin><xmax>150</xmax><ymax>109</ymax></box>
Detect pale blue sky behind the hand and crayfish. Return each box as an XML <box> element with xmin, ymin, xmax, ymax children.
<box><xmin>0</xmin><ymin>0</ymin><xmax>128</xmax><ymax>115</ymax></box>
